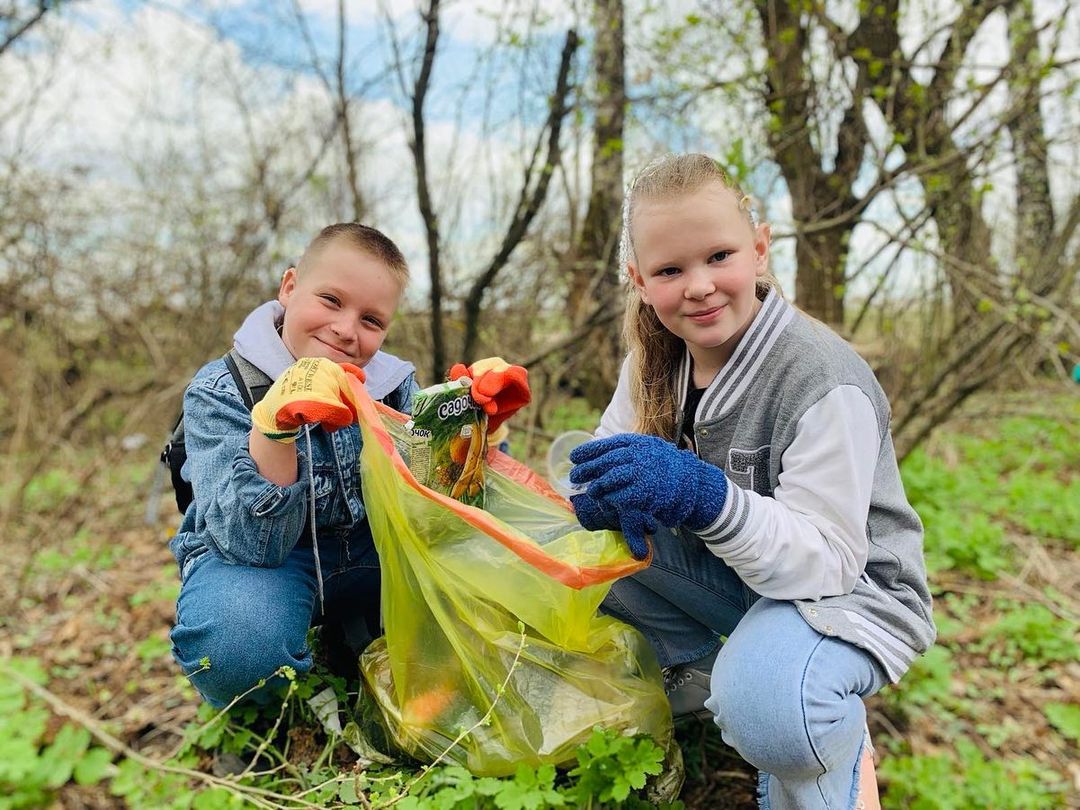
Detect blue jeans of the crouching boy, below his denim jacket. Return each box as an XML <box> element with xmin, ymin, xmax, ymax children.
<box><xmin>171</xmin><ymin>536</ymin><xmax>380</xmax><ymax>707</ymax></box>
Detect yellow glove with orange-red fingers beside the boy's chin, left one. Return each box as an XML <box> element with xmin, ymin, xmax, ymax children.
<box><xmin>252</xmin><ymin>357</ymin><xmax>365</xmax><ymax>444</ymax></box>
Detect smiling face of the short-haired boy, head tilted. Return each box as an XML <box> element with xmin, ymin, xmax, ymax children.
<box><xmin>278</xmin><ymin>239</ymin><xmax>402</xmax><ymax>367</ymax></box>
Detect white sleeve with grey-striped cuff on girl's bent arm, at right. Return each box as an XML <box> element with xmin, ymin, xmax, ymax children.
<box><xmin>697</xmin><ymin>386</ymin><xmax>881</xmax><ymax>599</ymax></box>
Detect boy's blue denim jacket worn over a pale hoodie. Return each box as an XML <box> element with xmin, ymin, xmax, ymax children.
<box><xmin>170</xmin><ymin>302</ymin><xmax>417</xmax><ymax>579</ymax></box>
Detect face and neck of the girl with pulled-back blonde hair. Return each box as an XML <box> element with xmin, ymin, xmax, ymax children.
<box><xmin>629</xmin><ymin>180</ymin><xmax>769</xmax><ymax>380</ymax></box>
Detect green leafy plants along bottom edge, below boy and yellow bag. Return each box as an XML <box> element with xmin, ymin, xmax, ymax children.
<box><xmin>0</xmin><ymin>658</ymin><xmax>683</xmax><ymax>810</ymax></box>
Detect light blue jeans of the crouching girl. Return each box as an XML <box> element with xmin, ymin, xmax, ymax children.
<box><xmin>602</xmin><ymin>529</ymin><xmax>887</xmax><ymax>810</ymax></box>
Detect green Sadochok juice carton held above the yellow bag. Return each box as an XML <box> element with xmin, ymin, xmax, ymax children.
<box><xmin>400</xmin><ymin>377</ymin><xmax>487</xmax><ymax>509</ymax></box>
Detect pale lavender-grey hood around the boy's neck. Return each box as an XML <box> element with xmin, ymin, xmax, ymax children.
<box><xmin>232</xmin><ymin>301</ymin><xmax>416</xmax><ymax>400</ymax></box>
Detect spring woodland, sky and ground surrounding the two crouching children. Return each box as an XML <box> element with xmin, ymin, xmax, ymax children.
<box><xmin>0</xmin><ymin>0</ymin><xmax>1080</xmax><ymax>808</ymax></box>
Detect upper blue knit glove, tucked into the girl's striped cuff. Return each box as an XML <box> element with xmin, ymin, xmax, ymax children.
<box><xmin>570</xmin><ymin>433</ymin><xmax>728</xmax><ymax>534</ymax></box>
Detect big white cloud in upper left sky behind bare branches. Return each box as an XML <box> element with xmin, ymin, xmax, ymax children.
<box><xmin>0</xmin><ymin>0</ymin><xmax>548</xmax><ymax>293</ymax></box>
